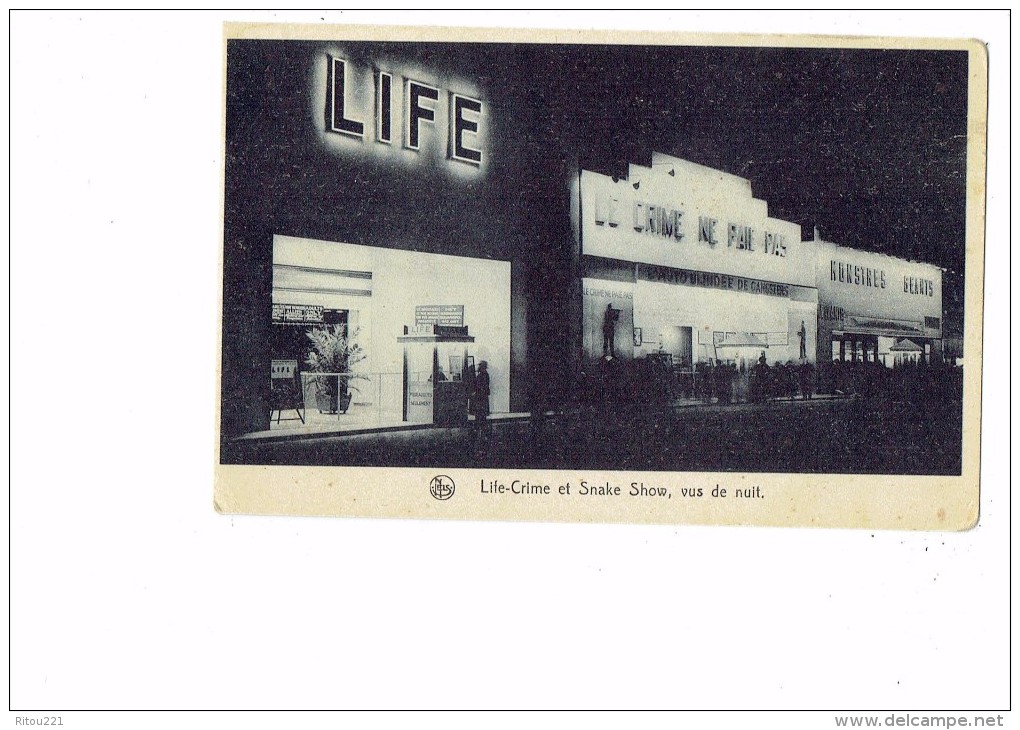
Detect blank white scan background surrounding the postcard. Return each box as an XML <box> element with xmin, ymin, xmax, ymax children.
<box><xmin>8</xmin><ymin>11</ymin><xmax>1011</xmax><ymax>727</ymax></box>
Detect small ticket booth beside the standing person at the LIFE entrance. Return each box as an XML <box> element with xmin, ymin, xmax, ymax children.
<box><xmin>397</xmin><ymin>324</ymin><xmax>474</xmax><ymax>426</ymax></box>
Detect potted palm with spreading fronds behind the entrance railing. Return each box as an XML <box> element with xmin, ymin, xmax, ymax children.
<box><xmin>305</xmin><ymin>324</ymin><xmax>365</xmax><ymax>413</ymax></box>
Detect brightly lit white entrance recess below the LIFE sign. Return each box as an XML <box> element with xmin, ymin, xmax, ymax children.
<box><xmin>266</xmin><ymin>236</ymin><xmax>510</xmax><ymax>430</ymax></box>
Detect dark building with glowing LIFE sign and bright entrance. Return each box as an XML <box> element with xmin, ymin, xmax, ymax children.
<box><xmin>220</xmin><ymin>40</ymin><xmax>569</xmax><ymax>442</ymax></box>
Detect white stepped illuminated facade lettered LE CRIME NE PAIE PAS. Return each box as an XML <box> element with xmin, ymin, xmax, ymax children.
<box><xmin>574</xmin><ymin>153</ymin><xmax>818</xmax><ymax>368</ymax></box>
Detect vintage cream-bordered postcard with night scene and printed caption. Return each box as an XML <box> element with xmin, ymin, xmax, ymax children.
<box><xmin>214</xmin><ymin>24</ymin><xmax>987</xmax><ymax>530</ymax></box>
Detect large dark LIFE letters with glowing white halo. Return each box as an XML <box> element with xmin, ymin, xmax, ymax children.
<box><xmin>325</xmin><ymin>56</ymin><xmax>485</xmax><ymax>165</ymax></box>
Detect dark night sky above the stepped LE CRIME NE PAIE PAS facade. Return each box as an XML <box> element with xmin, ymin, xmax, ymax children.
<box><xmin>522</xmin><ymin>47</ymin><xmax>967</xmax><ymax>279</ymax></box>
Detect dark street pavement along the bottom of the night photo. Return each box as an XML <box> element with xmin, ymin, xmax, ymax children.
<box><xmin>223</xmin><ymin>398</ymin><xmax>962</xmax><ymax>474</ymax></box>
